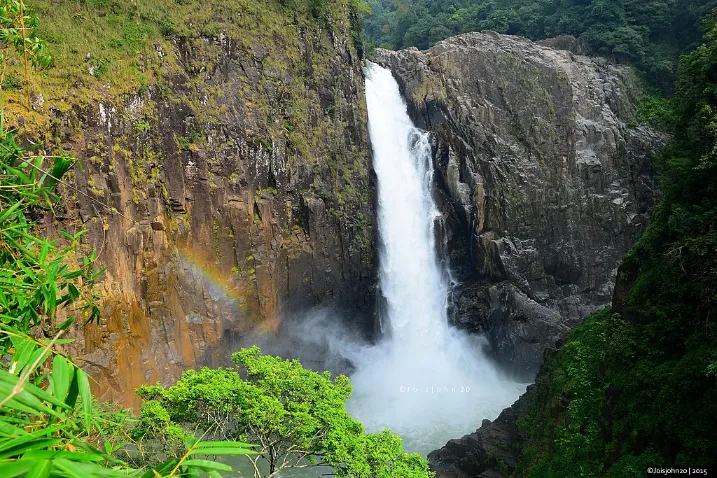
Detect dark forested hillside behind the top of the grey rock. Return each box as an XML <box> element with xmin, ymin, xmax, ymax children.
<box><xmin>366</xmin><ymin>0</ymin><xmax>717</xmax><ymax>92</ymax></box>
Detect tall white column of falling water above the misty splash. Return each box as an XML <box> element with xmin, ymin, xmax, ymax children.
<box><xmin>367</xmin><ymin>75</ymin><xmax>448</xmax><ymax>353</ymax></box>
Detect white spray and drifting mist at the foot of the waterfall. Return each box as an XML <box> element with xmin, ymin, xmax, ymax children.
<box><xmin>243</xmin><ymin>308</ymin><xmax>527</xmax><ymax>458</ymax></box>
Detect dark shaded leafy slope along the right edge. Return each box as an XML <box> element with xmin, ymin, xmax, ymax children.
<box><xmin>519</xmin><ymin>14</ymin><xmax>717</xmax><ymax>477</ymax></box>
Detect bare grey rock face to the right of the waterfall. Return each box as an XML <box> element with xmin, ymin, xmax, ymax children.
<box><xmin>376</xmin><ymin>32</ymin><xmax>663</xmax><ymax>379</ymax></box>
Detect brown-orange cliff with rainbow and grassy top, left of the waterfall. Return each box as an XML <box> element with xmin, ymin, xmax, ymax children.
<box><xmin>38</xmin><ymin>2</ymin><xmax>375</xmax><ymax>405</ymax></box>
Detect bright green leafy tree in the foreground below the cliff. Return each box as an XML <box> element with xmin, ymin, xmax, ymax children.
<box><xmin>137</xmin><ymin>347</ymin><xmax>432</xmax><ymax>478</ymax></box>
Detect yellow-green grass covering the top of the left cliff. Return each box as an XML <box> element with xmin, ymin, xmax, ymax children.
<box><xmin>11</xmin><ymin>0</ymin><xmax>357</xmax><ymax>108</ymax></box>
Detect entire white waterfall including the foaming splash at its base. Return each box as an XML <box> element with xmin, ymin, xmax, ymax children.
<box><xmin>348</xmin><ymin>63</ymin><xmax>525</xmax><ymax>454</ymax></box>
